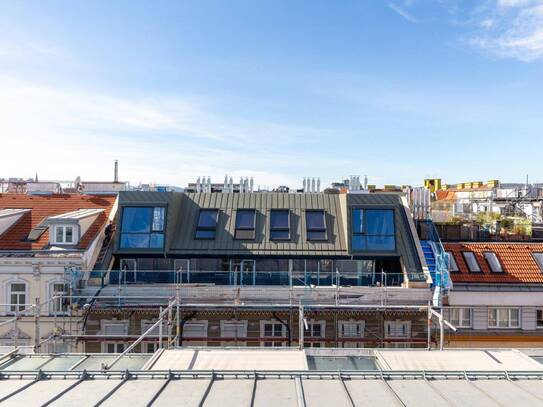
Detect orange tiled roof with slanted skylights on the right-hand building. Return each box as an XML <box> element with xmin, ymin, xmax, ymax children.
<box><xmin>443</xmin><ymin>242</ymin><xmax>543</xmax><ymax>284</ymax></box>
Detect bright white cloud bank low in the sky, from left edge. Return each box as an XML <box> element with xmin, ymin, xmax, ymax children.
<box><xmin>0</xmin><ymin>76</ymin><xmax>350</xmax><ymax>186</ymax></box>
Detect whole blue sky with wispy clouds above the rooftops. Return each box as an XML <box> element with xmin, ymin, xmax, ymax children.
<box><xmin>0</xmin><ymin>0</ymin><xmax>543</xmax><ymax>186</ymax></box>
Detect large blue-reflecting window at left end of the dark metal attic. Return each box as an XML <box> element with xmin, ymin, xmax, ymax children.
<box><xmin>121</xmin><ymin>207</ymin><xmax>165</xmax><ymax>249</ymax></box>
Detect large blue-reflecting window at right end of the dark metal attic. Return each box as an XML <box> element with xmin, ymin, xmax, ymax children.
<box><xmin>352</xmin><ymin>208</ymin><xmax>396</xmax><ymax>251</ymax></box>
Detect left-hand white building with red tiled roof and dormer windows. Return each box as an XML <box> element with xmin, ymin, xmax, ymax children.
<box><xmin>0</xmin><ymin>193</ymin><xmax>116</xmax><ymax>351</ymax></box>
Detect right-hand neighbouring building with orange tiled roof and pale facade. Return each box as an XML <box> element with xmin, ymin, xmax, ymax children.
<box><xmin>444</xmin><ymin>242</ymin><xmax>543</xmax><ymax>348</ymax></box>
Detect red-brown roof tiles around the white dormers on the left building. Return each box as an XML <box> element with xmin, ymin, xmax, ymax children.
<box><xmin>0</xmin><ymin>194</ymin><xmax>116</xmax><ymax>250</ymax></box>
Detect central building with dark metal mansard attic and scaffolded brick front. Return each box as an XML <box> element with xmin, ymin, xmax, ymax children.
<box><xmin>77</xmin><ymin>192</ymin><xmax>438</xmax><ymax>352</ymax></box>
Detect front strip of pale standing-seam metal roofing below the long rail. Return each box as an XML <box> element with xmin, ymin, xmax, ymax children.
<box><xmin>0</xmin><ymin>371</ymin><xmax>543</xmax><ymax>407</ymax></box>
